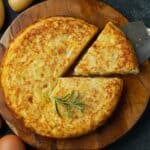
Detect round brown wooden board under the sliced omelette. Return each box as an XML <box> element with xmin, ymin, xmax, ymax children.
<box><xmin>0</xmin><ymin>0</ymin><xmax>150</xmax><ymax>150</ymax></box>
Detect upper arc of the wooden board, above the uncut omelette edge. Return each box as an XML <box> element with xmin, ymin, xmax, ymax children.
<box><xmin>1</xmin><ymin>0</ymin><xmax>127</xmax><ymax>47</ymax></box>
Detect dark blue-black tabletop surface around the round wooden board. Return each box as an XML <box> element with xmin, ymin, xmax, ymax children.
<box><xmin>0</xmin><ymin>0</ymin><xmax>150</xmax><ymax>150</ymax></box>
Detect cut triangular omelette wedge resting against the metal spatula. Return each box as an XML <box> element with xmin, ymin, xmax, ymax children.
<box><xmin>74</xmin><ymin>22</ymin><xmax>139</xmax><ymax>76</ymax></box>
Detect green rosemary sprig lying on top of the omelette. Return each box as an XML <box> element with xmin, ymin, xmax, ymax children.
<box><xmin>51</xmin><ymin>91</ymin><xmax>84</xmax><ymax>117</ymax></box>
